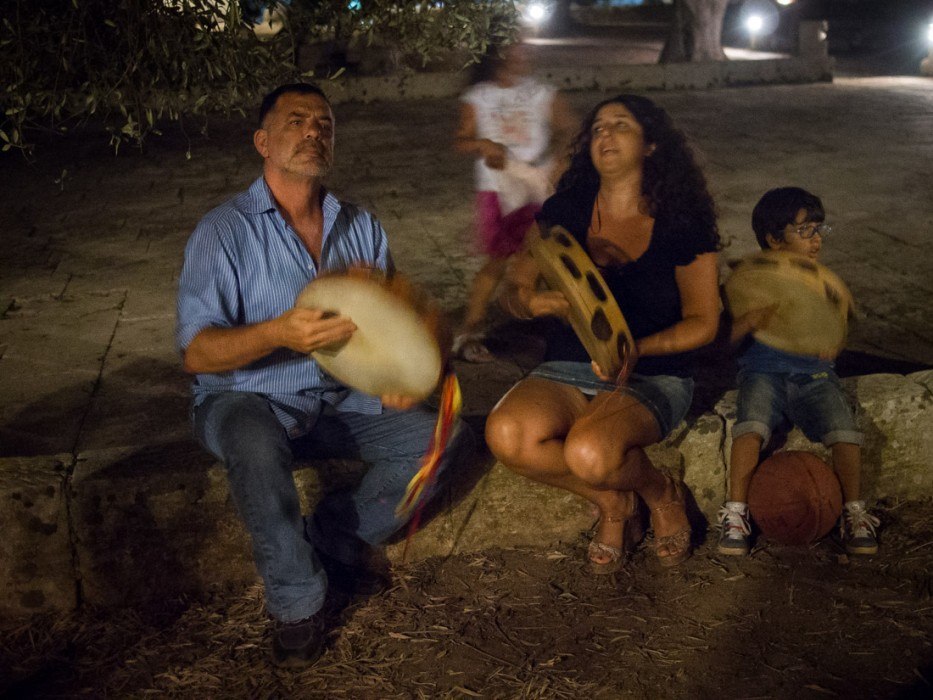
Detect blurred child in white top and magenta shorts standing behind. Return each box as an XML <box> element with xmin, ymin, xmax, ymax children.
<box><xmin>453</xmin><ymin>43</ymin><xmax>576</xmax><ymax>362</ymax></box>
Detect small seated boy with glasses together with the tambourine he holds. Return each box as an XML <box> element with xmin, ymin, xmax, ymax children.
<box><xmin>718</xmin><ymin>187</ymin><xmax>878</xmax><ymax>555</ymax></box>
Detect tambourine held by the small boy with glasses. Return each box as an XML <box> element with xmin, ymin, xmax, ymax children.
<box><xmin>725</xmin><ymin>250</ymin><xmax>855</xmax><ymax>357</ymax></box>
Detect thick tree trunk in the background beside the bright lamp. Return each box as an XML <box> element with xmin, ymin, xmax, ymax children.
<box><xmin>659</xmin><ymin>0</ymin><xmax>730</xmax><ymax>63</ymax></box>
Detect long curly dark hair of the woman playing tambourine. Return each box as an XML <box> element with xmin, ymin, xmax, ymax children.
<box><xmin>557</xmin><ymin>95</ymin><xmax>722</xmax><ymax>249</ymax></box>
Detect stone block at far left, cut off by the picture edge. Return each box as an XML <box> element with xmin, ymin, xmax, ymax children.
<box><xmin>0</xmin><ymin>455</ymin><xmax>77</xmax><ymax>617</ymax></box>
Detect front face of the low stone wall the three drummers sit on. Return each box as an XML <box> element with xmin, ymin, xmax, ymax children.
<box><xmin>7</xmin><ymin>370</ymin><xmax>933</xmax><ymax>613</ymax></box>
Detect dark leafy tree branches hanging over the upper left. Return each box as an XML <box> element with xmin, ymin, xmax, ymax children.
<box><xmin>0</xmin><ymin>0</ymin><xmax>515</xmax><ymax>154</ymax></box>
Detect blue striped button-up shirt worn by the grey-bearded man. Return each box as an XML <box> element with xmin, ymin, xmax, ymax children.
<box><xmin>175</xmin><ymin>177</ymin><xmax>392</xmax><ymax>437</ymax></box>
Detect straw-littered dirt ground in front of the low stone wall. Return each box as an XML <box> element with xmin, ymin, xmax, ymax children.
<box><xmin>0</xmin><ymin>501</ymin><xmax>933</xmax><ymax>699</ymax></box>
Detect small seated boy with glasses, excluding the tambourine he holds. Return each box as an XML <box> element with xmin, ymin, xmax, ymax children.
<box><xmin>718</xmin><ymin>187</ymin><xmax>878</xmax><ymax>555</ymax></box>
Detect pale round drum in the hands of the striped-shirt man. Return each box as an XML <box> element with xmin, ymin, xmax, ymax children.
<box><xmin>295</xmin><ymin>271</ymin><xmax>447</xmax><ymax>400</ymax></box>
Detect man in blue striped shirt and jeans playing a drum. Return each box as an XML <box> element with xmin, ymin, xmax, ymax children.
<box><xmin>176</xmin><ymin>84</ymin><xmax>472</xmax><ymax>666</ymax></box>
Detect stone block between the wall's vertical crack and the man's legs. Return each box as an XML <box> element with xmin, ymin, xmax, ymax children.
<box><xmin>70</xmin><ymin>441</ymin><xmax>256</xmax><ymax>606</ymax></box>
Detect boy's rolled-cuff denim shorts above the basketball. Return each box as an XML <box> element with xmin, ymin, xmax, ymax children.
<box><xmin>732</xmin><ymin>371</ymin><xmax>863</xmax><ymax>447</ymax></box>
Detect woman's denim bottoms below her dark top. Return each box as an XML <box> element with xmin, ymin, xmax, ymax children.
<box><xmin>528</xmin><ymin>361</ymin><xmax>693</xmax><ymax>440</ymax></box>
